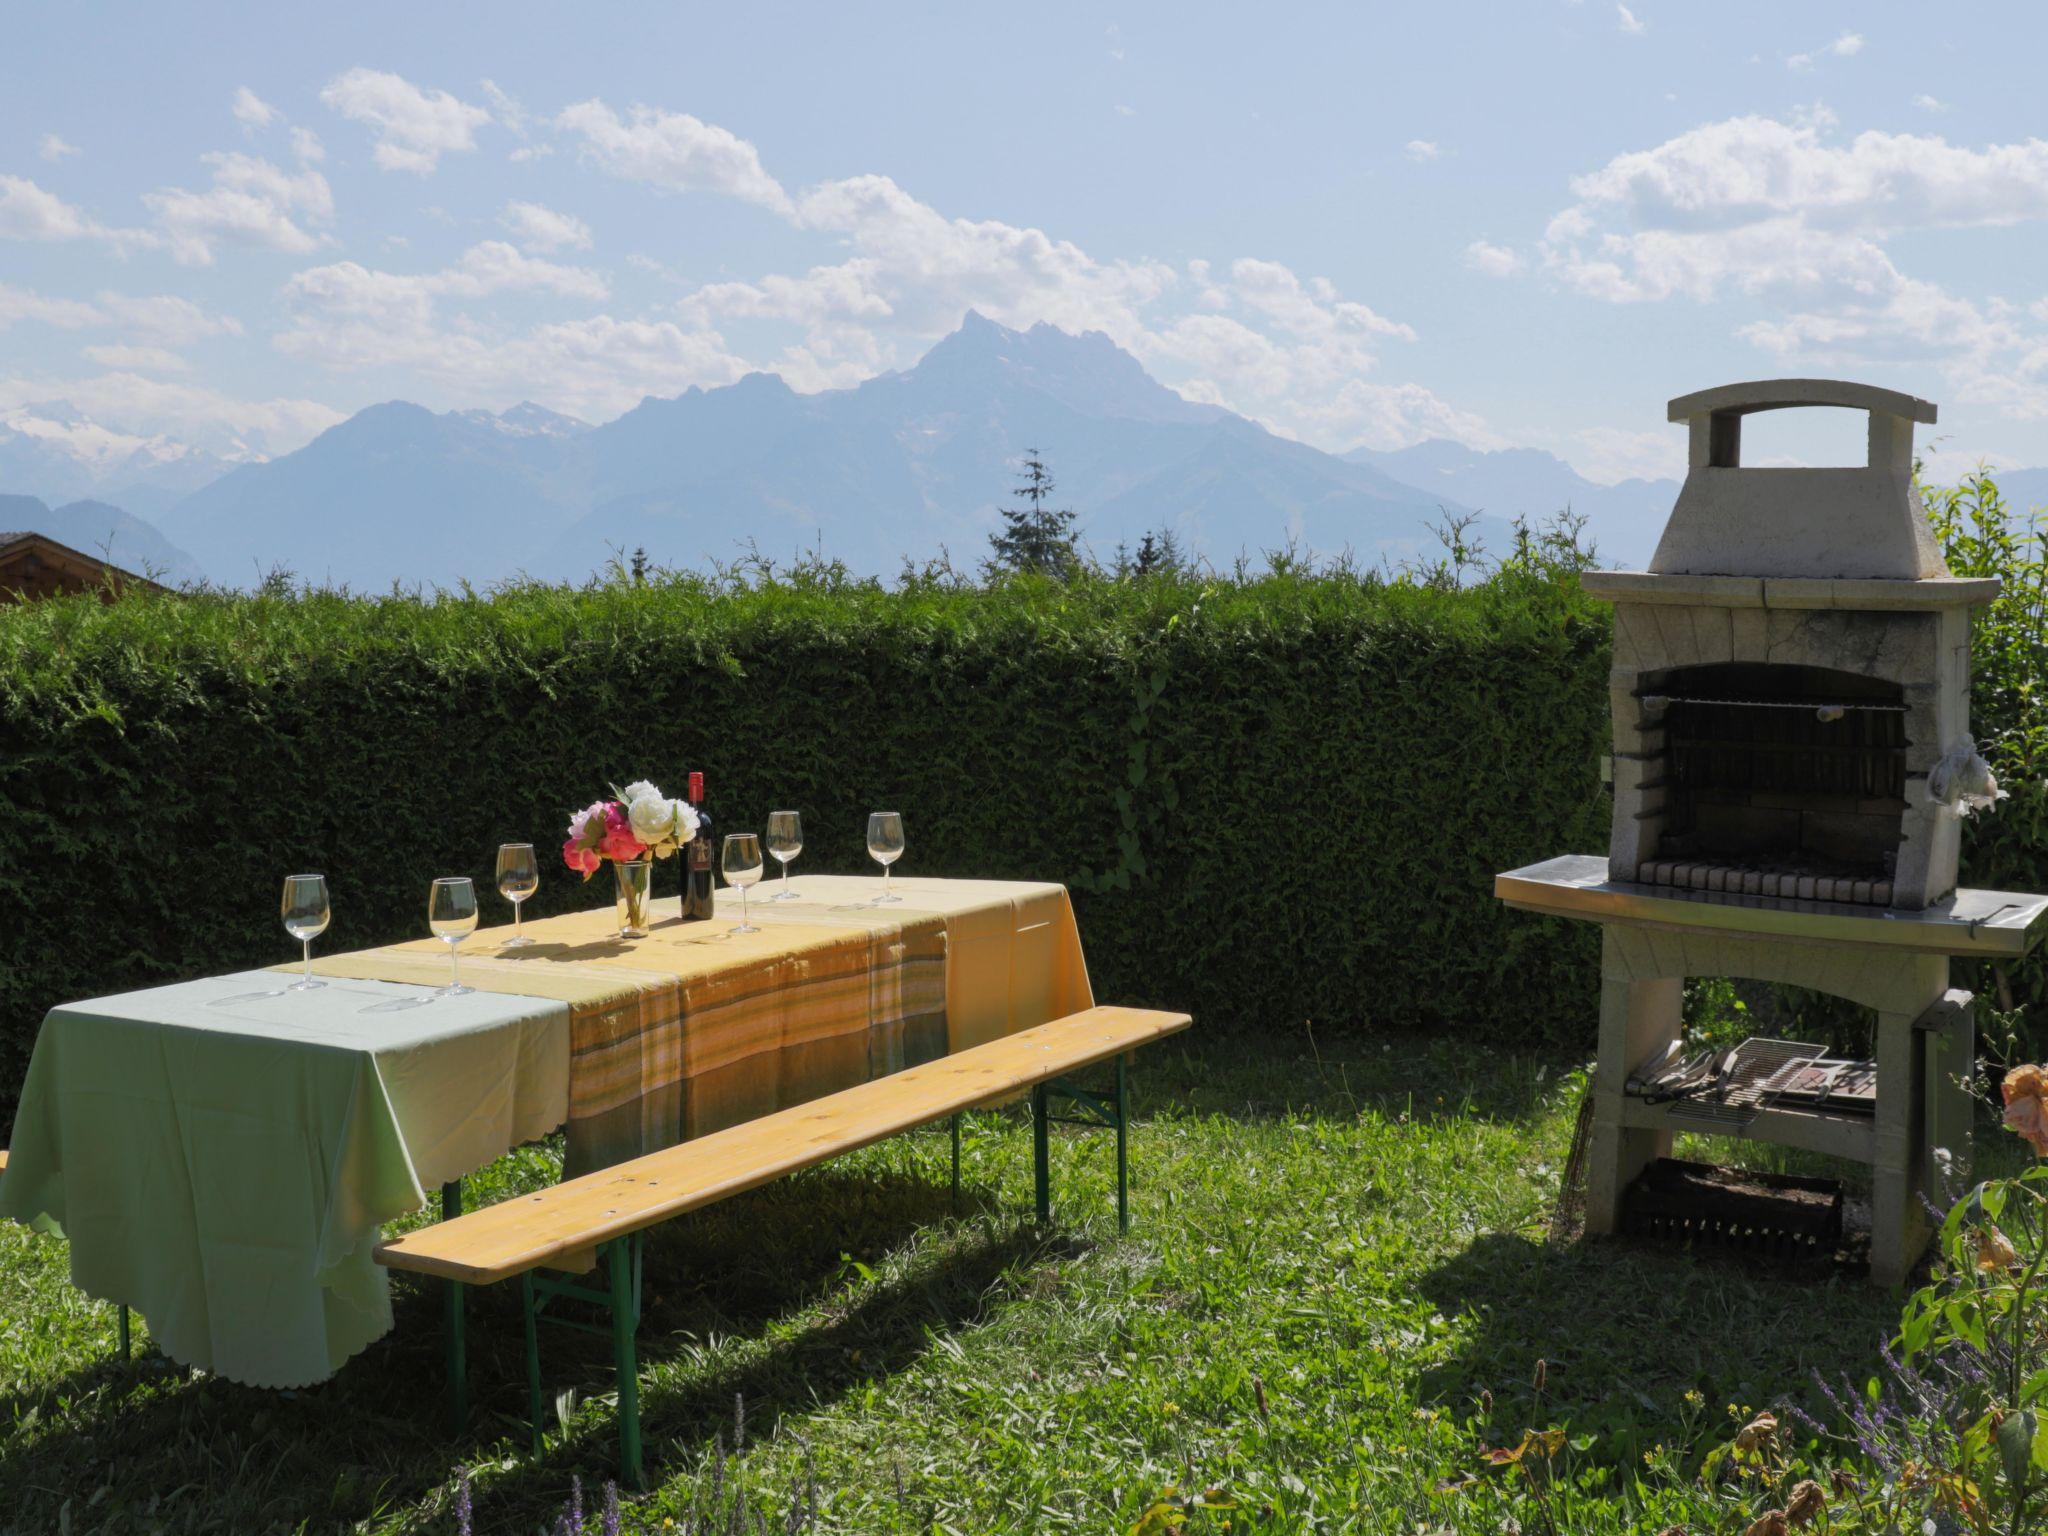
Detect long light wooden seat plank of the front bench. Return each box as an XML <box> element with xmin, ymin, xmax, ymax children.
<box><xmin>377</xmin><ymin>1008</ymin><xmax>1192</xmax><ymax>1284</ymax></box>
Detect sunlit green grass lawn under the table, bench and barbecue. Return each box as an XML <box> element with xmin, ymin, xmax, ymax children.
<box><xmin>0</xmin><ymin>1030</ymin><xmax>1989</xmax><ymax>1536</ymax></box>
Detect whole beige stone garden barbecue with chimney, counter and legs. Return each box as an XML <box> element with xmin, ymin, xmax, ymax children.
<box><xmin>1495</xmin><ymin>379</ymin><xmax>2048</xmax><ymax>1284</ymax></box>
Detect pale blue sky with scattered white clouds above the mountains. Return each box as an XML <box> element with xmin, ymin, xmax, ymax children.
<box><xmin>0</xmin><ymin>0</ymin><xmax>2048</xmax><ymax>479</ymax></box>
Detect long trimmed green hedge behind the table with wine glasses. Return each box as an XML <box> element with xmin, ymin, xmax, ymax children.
<box><xmin>0</xmin><ymin>575</ymin><xmax>1608</xmax><ymax>1118</ymax></box>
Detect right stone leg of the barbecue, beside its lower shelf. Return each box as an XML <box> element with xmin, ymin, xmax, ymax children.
<box><xmin>1870</xmin><ymin>954</ymin><xmax>1948</xmax><ymax>1286</ymax></box>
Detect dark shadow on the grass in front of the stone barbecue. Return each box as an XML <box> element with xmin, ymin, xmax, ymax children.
<box><xmin>1423</xmin><ymin>1233</ymin><xmax>1898</xmax><ymax>1473</ymax></box>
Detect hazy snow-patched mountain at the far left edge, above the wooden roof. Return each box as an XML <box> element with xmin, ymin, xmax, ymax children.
<box><xmin>0</xmin><ymin>399</ymin><xmax>256</xmax><ymax>516</ymax></box>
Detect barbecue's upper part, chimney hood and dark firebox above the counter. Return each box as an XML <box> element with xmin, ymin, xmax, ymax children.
<box><xmin>1583</xmin><ymin>379</ymin><xmax>1999</xmax><ymax>911</ymax></box>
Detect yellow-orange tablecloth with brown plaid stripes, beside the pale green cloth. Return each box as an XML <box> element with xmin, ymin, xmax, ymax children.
<box><xmin>299</xmin><ymin>874</ymin><xmax>1094</xmax><ymax>1176</ymax></box>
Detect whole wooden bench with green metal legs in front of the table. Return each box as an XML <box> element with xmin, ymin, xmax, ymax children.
<box><xmin>377</xmin><ymin>1008</ymin><xmax>1192</xmax><ymax>1487</ymax></box>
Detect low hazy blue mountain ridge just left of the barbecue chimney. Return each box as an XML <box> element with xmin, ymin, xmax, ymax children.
<box><xmin>1343</xmin><ymin>438</ymin><xmax>1679</xmax><ymax>571</ymax></box>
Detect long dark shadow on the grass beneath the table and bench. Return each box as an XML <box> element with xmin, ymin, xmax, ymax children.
<box><xmin>0</xmin><ymin>1169</ymin><xmax>1079</xmax><ymax>1534</ymax></box>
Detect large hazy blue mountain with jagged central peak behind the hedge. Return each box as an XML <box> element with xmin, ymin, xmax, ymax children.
<box><xmin>164</xmin><ymin>313</ymin><xmax>1505</xmax><ymax>588</ymax></box>
